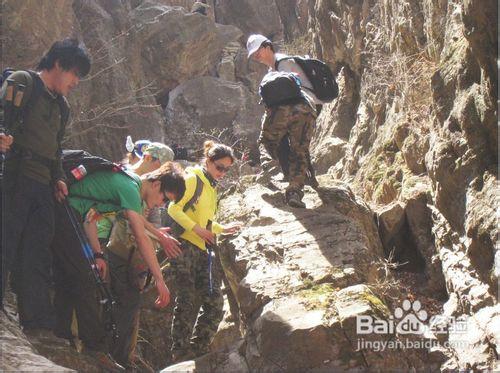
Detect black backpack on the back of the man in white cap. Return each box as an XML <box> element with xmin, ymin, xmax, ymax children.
<box><xmin>275</xmin><ymin>56</ymin><xmax>339</xmax><ymax>102</ymax></box>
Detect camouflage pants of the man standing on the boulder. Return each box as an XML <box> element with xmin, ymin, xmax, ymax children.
<box><xmin>259</xmin><ymin>103</ymin><xmax>316</xmax><ymax>191</ymax></box>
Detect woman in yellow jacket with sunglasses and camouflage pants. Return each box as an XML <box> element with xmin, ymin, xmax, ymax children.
<box><xmin>168</xmin><ymin>141</ymin><xmax>239</xmax><ymax>362</ymax></box>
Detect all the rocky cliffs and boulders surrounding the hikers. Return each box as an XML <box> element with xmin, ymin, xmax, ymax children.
<box><xmin>2</xmin><ymin>0</ymin><xmax>500</xmax><ymax>372</ymax></box>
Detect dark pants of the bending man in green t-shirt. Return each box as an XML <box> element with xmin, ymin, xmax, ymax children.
<box><xmin>52</xmin><ymin>199</ymin><xmax>107</xmax><ymax>352</ymax></box>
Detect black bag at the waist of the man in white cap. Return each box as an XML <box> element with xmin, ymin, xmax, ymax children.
<box><xmin>259</xmin><ymin>71</ymin><xmax>304</xmax><ymax>107</ymax></box>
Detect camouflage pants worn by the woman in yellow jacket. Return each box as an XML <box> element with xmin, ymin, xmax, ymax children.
<box><xmin>171</xmin><ymin>239</ymin><xmax>223</xmax><ymax>356</ymax></box>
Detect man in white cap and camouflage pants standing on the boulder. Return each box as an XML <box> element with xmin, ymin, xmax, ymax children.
<box><xmin>247</xmin><ymin>35</ymin><xmax>317</xmax><ymax>208</ymax></box>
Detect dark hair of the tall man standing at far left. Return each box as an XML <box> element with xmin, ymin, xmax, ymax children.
<box><xmin>37</xmin><ymin>38</ymin><xmax>90</xmax><ymax>78</ymax></box>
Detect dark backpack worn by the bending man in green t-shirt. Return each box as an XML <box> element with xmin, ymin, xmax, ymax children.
<box><xmin>61</xmin><ymin>150</ymin><xmax>130</xmax><ymax>185</ymax></box>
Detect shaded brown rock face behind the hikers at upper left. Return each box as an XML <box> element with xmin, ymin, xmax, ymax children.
<box><xmin>2</xmin><ymin>0</ymin><xmax>262</xmax><ymax>159</ymax></box>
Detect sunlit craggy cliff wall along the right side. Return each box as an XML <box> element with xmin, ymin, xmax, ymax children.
<box><xmin>309</xmin><ymin>1</ymin><xmax>500</xmax><ymax>369</ymax></box>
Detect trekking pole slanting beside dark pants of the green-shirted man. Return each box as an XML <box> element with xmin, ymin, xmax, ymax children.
<box><xmin>62</xmin><ymin>198</ymin><xmax>118</xmax><ymax>341</ymax></box>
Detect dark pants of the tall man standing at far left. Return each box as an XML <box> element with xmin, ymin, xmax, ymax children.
<box><xmin>2</xmin><ymin>175</ymin><xmax>54</xmax><ymax>329</ymax></box>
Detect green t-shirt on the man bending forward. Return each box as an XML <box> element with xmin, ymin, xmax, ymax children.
<box><xmin>69</xmin><ymin>171</ymin><xmax>142</xmax><ymax>217</ymax></box>
